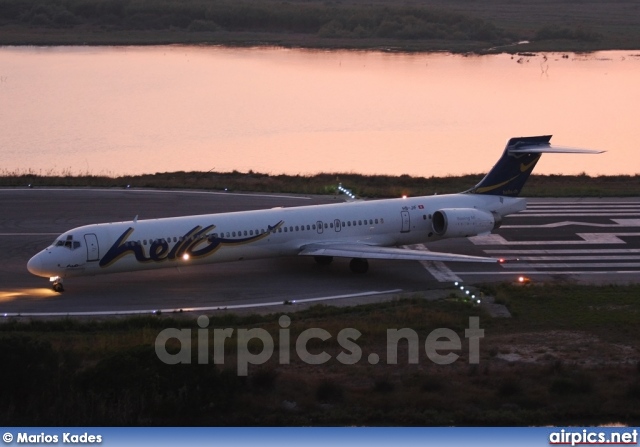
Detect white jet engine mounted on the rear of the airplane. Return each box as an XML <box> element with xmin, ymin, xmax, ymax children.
<box><xmin>431</xmin><ymin>208</ymin><xmax>501</xmax><ymax>238</ymax></box>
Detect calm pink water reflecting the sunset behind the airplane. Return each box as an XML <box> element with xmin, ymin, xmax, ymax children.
<box><xmin>0</xmin><ymin>46</ymin><xmax>640</xmax><ymax>176</ymax></box>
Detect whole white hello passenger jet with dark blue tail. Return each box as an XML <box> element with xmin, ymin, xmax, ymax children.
<box><xmin>27</xmin><ymin>135</ymin><xmax>604</xmax><ymax>292</ymax></box>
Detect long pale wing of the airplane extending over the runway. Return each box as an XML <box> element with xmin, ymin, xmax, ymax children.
<box><xmin>298</xmin><ymin>244</ymin><xmax>503</xmax><ymax>263</ymax></box>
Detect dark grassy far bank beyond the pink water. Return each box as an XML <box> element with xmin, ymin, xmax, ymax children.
<box><xmin>0</xmin><ymin>0</ymin><xmax>640</xmax><ymax>54</ymax></box>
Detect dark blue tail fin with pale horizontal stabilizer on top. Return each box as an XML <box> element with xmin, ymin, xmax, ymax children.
<box><xmin>465</xmin><ymin>135</ymin><xmax>604</xmax><ymax>197</ymax></box>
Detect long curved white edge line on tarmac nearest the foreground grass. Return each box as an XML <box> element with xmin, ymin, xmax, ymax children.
<box><xmin>0</xmin><ymin>289</ymin><xmax>402</xmax><ymax>318</ymax></box>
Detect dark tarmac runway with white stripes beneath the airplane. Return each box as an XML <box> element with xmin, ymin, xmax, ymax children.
<box><xmin>0</xmin><ymin>188</ymin><xmax>640</xmax><ymax>316</ymax></box>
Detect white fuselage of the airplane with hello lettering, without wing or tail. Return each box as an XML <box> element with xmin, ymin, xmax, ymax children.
<box><xmin>28</xmin><ymin>194</ymin><xmax>526</xmax><ymax>278</ymax></box>
